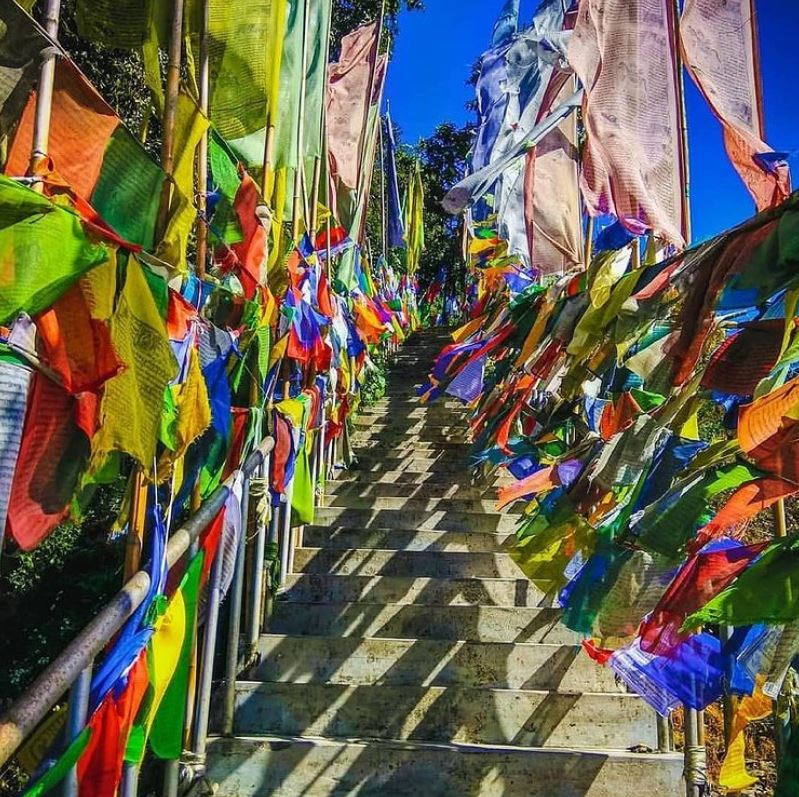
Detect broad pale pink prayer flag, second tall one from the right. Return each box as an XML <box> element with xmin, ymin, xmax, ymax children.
<box><xmin>569</xmin><ymin>0</ymin><xmax>685</xmax><ymax>246</ymax></box>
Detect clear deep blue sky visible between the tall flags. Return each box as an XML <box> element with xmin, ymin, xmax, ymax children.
<box><xmin>387</xmin><ymin>0</ymin><xmax>799</xmax><ymax>240</ymax></box>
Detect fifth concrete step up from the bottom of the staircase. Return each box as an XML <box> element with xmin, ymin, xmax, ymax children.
<box><xmin>281</xmin><ymin>573</ymin><xmax>544</xmax><ymax>607</ymax></box>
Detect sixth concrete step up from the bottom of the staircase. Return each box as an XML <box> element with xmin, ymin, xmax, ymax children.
<box><xmin>294</xmin><ymin>548</ymin><xmax>522</xmax><ymax>578</ymax></box>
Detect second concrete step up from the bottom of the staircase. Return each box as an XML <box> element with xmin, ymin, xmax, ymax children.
<box><xmin>235</xmin><ymin>681</ymin><xmax>657</xmax><ymax>749</ymax></box>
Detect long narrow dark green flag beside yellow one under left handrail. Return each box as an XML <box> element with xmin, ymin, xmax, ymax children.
<box><xmin>150</xmin><ymin>551</ymin><xmax>205</xmax><ymax>761</ymax></box>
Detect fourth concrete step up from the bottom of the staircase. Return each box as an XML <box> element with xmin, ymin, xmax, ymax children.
<box><xmin>269</xmin><ymin>603</ymin><xmax>568</xmax><ymax>645</ymax></box>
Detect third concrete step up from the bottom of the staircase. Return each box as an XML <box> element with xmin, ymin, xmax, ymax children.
<box><xmin>253</xmin><ymin>635</ymin><xmax>625</xmax><ymax>693</ymax></box>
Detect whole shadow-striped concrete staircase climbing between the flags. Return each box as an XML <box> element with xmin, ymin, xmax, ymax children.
<box><xmin>208</xmin><ymin>333</ymin><xmax>684</xmax><ymax>797</ymax></box>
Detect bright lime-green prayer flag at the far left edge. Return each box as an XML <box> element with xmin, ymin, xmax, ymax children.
<box><xmin>0</xmin><ymin>177</ymin><xmax>108</xmax><ymax>323</ymax></box>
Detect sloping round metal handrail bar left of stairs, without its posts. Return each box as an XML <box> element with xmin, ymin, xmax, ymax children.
<box><xmin>0</xmin><ymin>437</ymin><xmax>275</xmax><ymax>766</ymax></box>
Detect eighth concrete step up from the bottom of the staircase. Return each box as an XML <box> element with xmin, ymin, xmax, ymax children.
<box><xmin>314</xmin><ymin>506</ymin><xmax>518</xmax><ymax>533</ymax></box>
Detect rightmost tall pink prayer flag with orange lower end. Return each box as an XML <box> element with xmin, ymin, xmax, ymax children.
<box><xmin>680</xmin><ymin>0</ymin><xmax>791</xmax><ymax>210</ymax></box>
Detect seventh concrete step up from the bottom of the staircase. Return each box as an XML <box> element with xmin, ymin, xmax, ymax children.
<box><xmin>302</xmin><ymin>526</ymin><xmax>516</xmax><ymax>553</ymax></box>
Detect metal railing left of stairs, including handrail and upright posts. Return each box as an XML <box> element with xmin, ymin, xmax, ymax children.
<box><xmin>0</xmin><ymin>437</ymin><xmax>290</xmax><ymax>797</ymax></box>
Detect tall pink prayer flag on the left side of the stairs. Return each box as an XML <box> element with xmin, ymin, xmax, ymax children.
<box><xmin>327</xmin><ymin>22</ymin><xmax>378</xmax><ymax>190</ymax></box>
